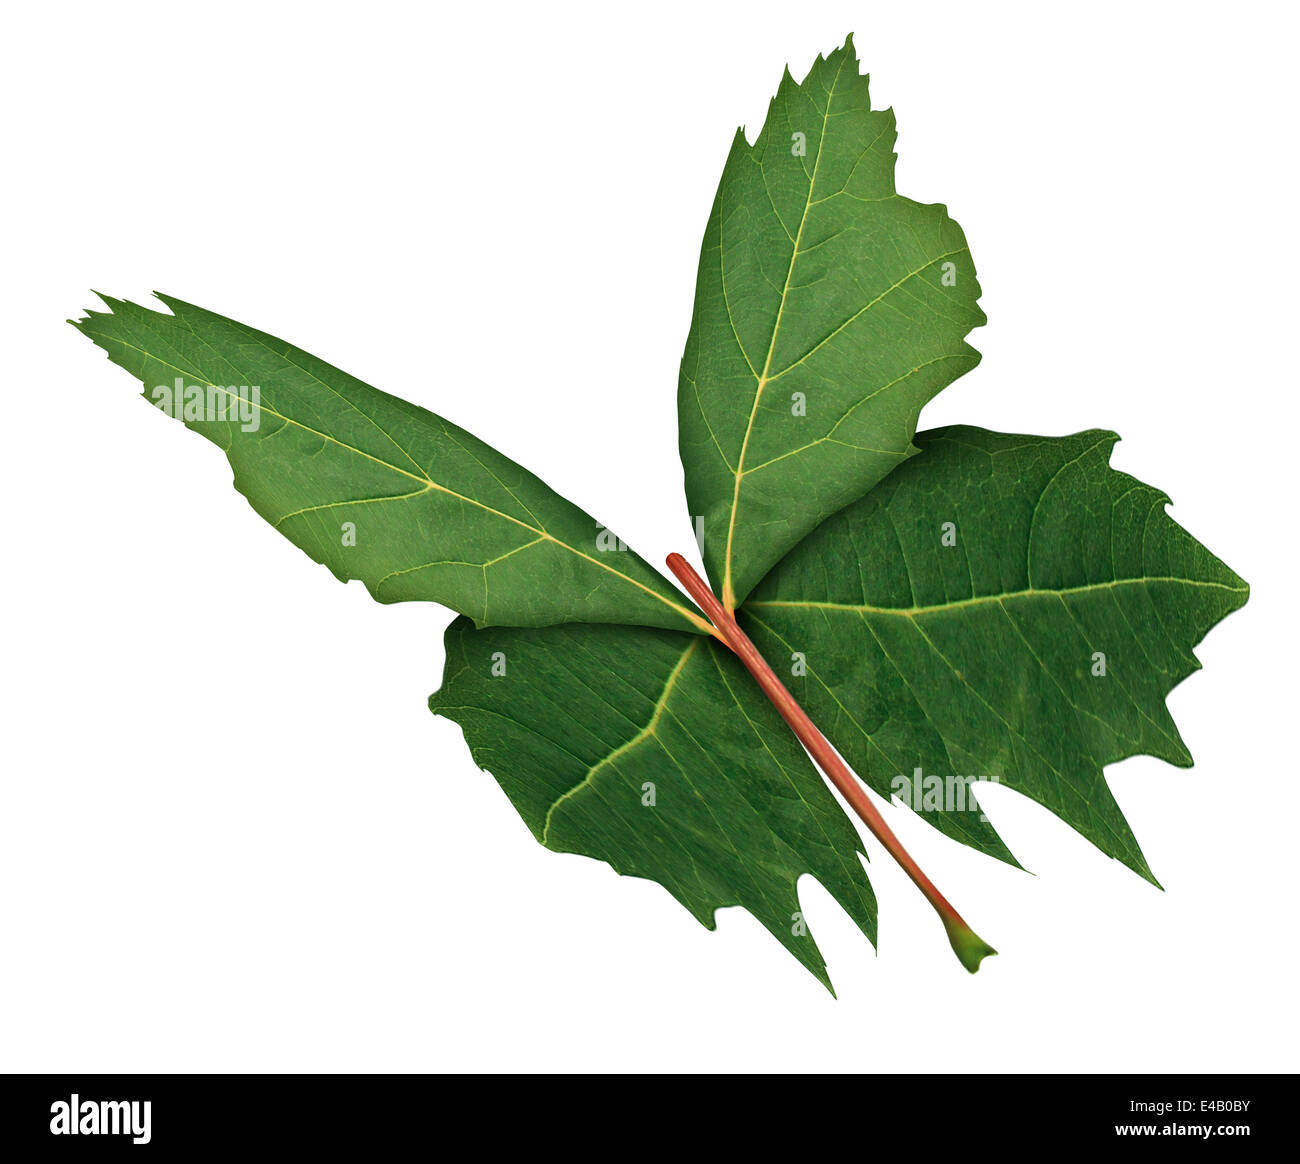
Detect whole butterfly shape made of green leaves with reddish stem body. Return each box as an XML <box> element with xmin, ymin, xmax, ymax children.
<box><xmin>75</xmin><ymin>40</ymin><xmax>1248</xmax><ymax>986</ymax></box>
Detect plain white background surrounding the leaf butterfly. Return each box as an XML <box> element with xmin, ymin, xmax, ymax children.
<box><xmin>0</xmin><ymin>0</ymin><xmax>1300</xmax><ymax>1071</ymax></box>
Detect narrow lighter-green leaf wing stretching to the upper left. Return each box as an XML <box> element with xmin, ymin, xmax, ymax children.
<box><xmin>74</xmin><ymin>295</ymin><xmax>707</xmax><ymax>632</ymax></box>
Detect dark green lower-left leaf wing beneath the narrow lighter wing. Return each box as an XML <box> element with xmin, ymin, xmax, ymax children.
<box><xmin>429</xmin><ymin>619</ymin><xmax>876</xmax><ymax>987</ymax></box>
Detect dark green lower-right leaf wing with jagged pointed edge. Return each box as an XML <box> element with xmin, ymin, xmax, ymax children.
<box><xmin>740</xmin><ymin>428</ymin><xmax>1248</xmax><ymax>880</ymax></box>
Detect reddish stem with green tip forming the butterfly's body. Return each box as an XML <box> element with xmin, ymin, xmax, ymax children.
<box><xmin>668</xmin><ymin>554</ymin><xmax>997</xmax><ymax>974</ymax></box>
